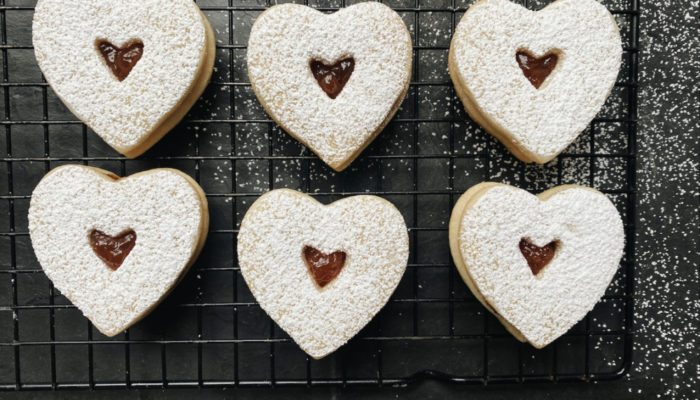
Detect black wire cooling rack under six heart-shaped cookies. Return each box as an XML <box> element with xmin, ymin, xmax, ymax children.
<box><xmin>0</xmin><ymin>0</ymin><xmax>639</xmax><ymax>390</ymax></box>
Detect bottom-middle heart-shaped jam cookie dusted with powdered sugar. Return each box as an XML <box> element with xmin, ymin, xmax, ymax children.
<box><xmin>238</xmin><ymin>189</ymin><xmax>408</xmax><ymax>358</ymax></box>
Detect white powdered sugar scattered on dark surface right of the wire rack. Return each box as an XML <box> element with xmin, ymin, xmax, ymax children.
<box><xmin>625</xmin><ymin>0</ymin><xmax>700</xmax><ymax>400</ymax></box>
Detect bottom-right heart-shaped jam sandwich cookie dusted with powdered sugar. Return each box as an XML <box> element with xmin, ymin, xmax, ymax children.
<box><xmin>449</xmin><ymin>182</ymin><xmax>625</xmax><ymax>348</ymax></box>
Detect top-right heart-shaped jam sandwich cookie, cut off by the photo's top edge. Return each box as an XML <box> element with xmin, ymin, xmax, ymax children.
<box><xmin>448</xmin><ymin>0</ymin><xmax>622</xmax><ymax>163</ymax></box>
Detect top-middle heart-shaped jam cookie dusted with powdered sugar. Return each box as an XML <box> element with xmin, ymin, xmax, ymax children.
<box><xmin>248</xmin><ymin>2</ymin><xmax>412</xmax><ymax>171</ymax></box>
